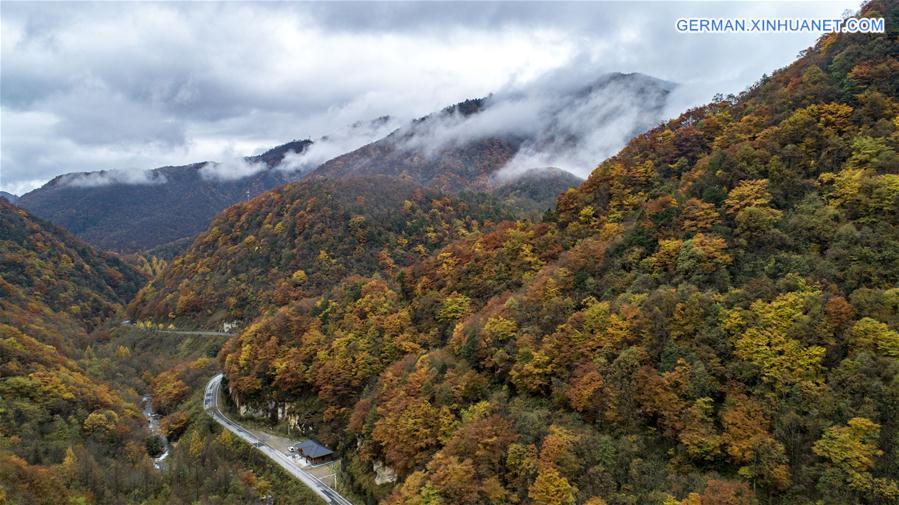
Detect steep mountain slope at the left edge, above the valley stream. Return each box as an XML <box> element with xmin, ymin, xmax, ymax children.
<box><xmin>0</xmin><ymin>201</ymin><xmax>146</xmax><ymax>504</ymax></box>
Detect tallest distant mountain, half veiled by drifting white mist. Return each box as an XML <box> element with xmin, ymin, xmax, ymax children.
<box><xmin>313</xmin><ymin>74</ymin><xmax>674</xmax><ymax>193</ymax></box>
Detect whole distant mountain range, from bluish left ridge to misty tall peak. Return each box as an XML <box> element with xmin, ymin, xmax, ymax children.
<box><xmin>18</xmin><ymin>74</ymin><xmax>673</xmax><ymax>252</ymax></box>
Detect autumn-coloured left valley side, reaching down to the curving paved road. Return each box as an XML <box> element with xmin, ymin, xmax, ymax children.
<box><xmin>0</xmin><ymin>202</ymin><xmax>326</xmax><ymax>505</ymax></box>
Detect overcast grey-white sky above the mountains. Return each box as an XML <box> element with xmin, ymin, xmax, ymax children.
<box><xmin>0</xmin><ymin>1</ymin><xmax>860</xmax><ymax>194</ymax></box>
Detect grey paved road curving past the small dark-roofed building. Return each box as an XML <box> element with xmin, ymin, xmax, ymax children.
<box><xmin>203</xmin><ymin>374</ymin><xmax>353</xmax><ymax>505</ymax></box>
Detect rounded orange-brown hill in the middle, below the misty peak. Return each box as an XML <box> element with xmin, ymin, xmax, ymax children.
<box><xmin>131</xmin><ymin>176</ymin><xmax>509</xmax><ymax>322</ymax></box>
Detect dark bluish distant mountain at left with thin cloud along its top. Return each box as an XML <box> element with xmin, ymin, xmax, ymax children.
<box><xmin>18</xmin><ymin>140</ymin><xmax>311</xmax><ymax>252</ymax></box>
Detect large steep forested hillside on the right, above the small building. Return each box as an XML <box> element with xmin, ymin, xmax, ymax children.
<box><xmin>204</xmin><ymin>1</ymin><xmax>899</xmax><ymax>505</ymax></box>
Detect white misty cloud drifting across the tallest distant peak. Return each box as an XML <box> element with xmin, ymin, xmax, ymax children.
<box><xmin>397</xmin><ymin>68</ymin><xmax>683</xmax><ymax>178</ymax></box>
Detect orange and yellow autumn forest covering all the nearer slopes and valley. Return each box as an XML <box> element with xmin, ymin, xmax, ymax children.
<box><xmin>0</xmin><ymin>0</ymin><xmax>899</xmax><ymax>505</ymax></box>
